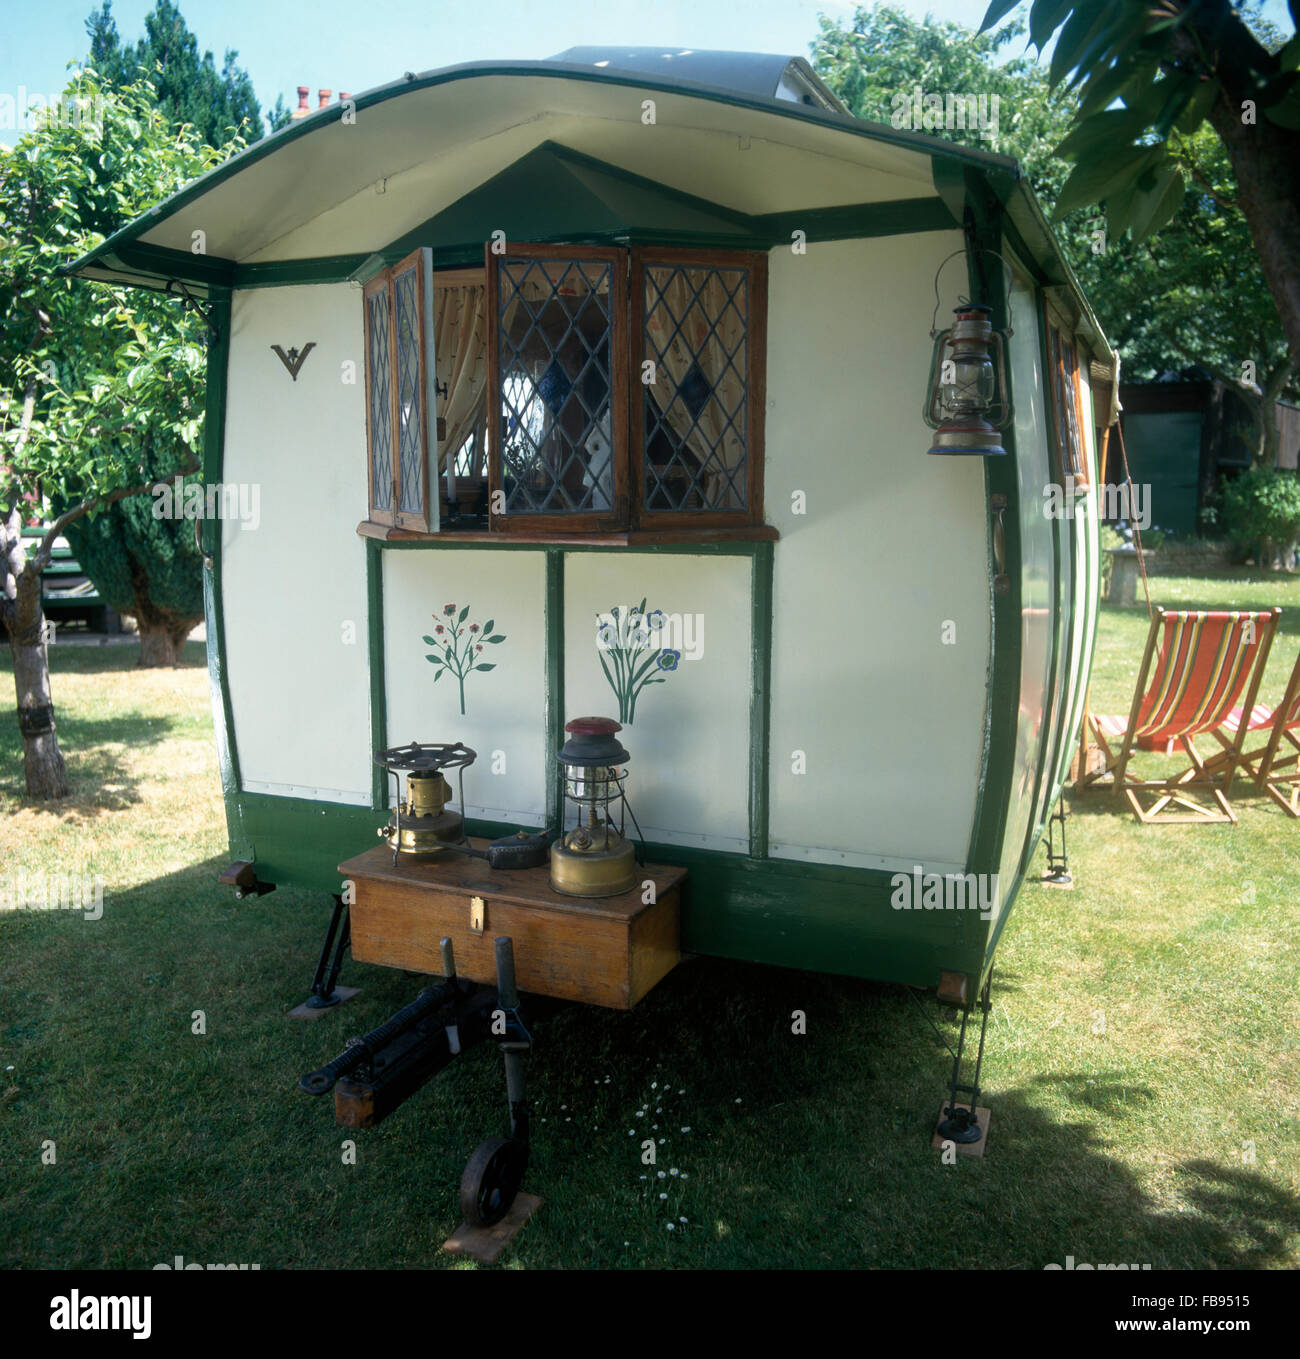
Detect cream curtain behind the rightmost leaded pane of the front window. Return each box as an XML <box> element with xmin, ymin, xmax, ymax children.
<box><xmin>645</xmin><ymin>266</ymin><xmax>747</xmax><ymax>506</ymax></box>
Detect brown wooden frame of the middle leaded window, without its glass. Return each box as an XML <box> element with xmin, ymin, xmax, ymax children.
<box><xmin>484</xmin><ymin>243</ymin><xmax>629</xmax><ymax>537</ymax></box>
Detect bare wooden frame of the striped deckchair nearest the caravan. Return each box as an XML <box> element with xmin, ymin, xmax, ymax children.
<box><xmin>1089</xmin><ymin>607</ymin><xmax>1285</xmax><ymax>826</ymax></box>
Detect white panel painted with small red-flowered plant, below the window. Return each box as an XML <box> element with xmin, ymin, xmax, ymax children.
<box><xmin>383</xmin><ymin>548</ymin><xmax>547</xmax><ymax>826</ymax></box>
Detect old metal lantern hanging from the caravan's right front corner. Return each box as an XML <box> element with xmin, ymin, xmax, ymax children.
<box><xmin>925</xmin><ymin>303</ymin><xmax>1012</xmax><ymax>458</ymax></box>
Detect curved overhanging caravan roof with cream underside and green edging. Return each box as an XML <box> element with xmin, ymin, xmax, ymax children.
<box><xmin>67</xmin><ymin>49</ymin><xmax>1113</xmax><ymax>380</ymax></box>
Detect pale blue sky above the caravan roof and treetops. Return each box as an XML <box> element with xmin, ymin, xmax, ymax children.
<box><xmin>0</xmin><ymin>0</ymin><xmax>1290</xmax><ymax>145</ymax></box>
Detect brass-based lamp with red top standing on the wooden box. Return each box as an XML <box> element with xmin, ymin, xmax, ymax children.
<box><xmin>550</xmin><ymin>718</ymin><xmax>637</xmax><ymax>897</ymax></box>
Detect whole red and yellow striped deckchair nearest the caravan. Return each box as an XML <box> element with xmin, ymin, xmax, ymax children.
<box><xmin>1089</xmin><ymin>607</ymin><xmax>1282</xmax><ymax>825</ymax></box>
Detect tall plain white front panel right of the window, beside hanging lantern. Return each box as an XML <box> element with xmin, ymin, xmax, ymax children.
<box><xmin>765</xmin><ymin>232</ymin><xmax>990</xmax><ymax>871</ymax></box>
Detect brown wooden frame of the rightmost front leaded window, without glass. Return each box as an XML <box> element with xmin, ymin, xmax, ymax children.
<box><xmin>628</xmin><ymin>246</ymin><xmax>768</xmax><ymax>529</ymax></box>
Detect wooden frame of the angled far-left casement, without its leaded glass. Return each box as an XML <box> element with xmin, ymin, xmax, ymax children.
<box><xmin>361</xmin><ymin>247</ymin><xmax>439</xmax><ymax>533</ymax></box>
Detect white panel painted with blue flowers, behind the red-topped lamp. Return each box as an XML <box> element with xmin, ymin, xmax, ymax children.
<box><xmin>564</xmin><ymin>553</ymin><xmax>753</xmax><ymax>852</ymax></box>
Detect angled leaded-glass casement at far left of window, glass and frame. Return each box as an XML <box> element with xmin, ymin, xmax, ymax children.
<box><xmin>363</xmin><ymin>247</ymin><xmax>439</xmax><ymax>533</ymax></box>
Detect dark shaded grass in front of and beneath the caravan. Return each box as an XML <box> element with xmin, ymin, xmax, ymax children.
<box><xmin>0</xmin><ymin>855</ymin><xmax>1297</xmax><ymax>1269</ymax></box>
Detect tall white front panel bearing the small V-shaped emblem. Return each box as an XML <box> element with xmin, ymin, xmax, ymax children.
<box><xmin>221</xmin><ymin>284</ymin><xmax>371</xmax><ymax>803</ymax></box>
